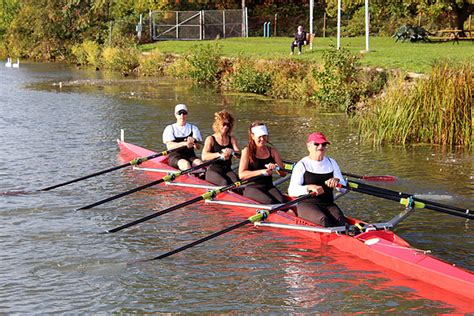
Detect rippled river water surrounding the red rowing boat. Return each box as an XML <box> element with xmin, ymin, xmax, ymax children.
<box><xmin>0</xmin><ymin>63</ymin><xmax>474</xmax><ymax>314</ymax></box>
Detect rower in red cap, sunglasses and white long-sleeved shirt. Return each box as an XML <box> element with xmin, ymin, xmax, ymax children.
<box><xmin>288</xmin><ymin>133</ymin><xmax>346</xmax><ymax>227</ymax></box>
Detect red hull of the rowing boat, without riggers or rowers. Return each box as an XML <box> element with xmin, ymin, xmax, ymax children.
<box><xmin>118</xmin><ymin>141</ymin><xmax>474</xmax><ymax>303</ymax></box>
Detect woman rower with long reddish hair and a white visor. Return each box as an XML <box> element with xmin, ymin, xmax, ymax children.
<box><xmin>239</xmin><ymin>121</ymin><xmax>285</xmax><ymax>204</ymax></box>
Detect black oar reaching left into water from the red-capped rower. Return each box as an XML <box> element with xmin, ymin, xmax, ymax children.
<box><xmin>143</xmin><ymin>192</ymin><xmax>315</xmax><ymax>261</ymax></box>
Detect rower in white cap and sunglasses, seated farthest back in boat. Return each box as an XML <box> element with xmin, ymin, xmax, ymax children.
<box><xmin>163</xmin><ymin>104</ymin><xmax>202</xmax><ymax>170</ymax></box>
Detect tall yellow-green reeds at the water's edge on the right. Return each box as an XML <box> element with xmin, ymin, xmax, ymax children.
<box><xmin>353</xmin><ymin>61</ymin><xmax>474</xmax><ymax>146</ymax></box>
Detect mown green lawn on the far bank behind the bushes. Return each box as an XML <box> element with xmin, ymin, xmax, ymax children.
<box><xmin>141</xmin><ymin>37</ymin><xmax>474</xmax><ymax>73</ymax></box>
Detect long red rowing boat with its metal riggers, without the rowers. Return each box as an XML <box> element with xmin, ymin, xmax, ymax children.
<box><xmin>118</xmin><ymin>135</ymin><xmax>474</xmax><ymax>299</ymax></box>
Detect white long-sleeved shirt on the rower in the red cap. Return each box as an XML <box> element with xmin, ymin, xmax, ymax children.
<box><xmin>288</xmin><ymin>156</ymin><xmax>346</xmax><ymax>197</ymax></box>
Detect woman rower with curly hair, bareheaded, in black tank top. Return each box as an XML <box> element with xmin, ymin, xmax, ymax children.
<box><xmin>202</xmin><ymin>110</ymin><xmax>240</xmax><ymax>186</ymax></box>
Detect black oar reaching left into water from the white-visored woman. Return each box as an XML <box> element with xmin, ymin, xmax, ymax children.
<box><xmin>105</xmin><ymin>175</ymin><xmax>263</xmax><ymax>233</ymax></box>
